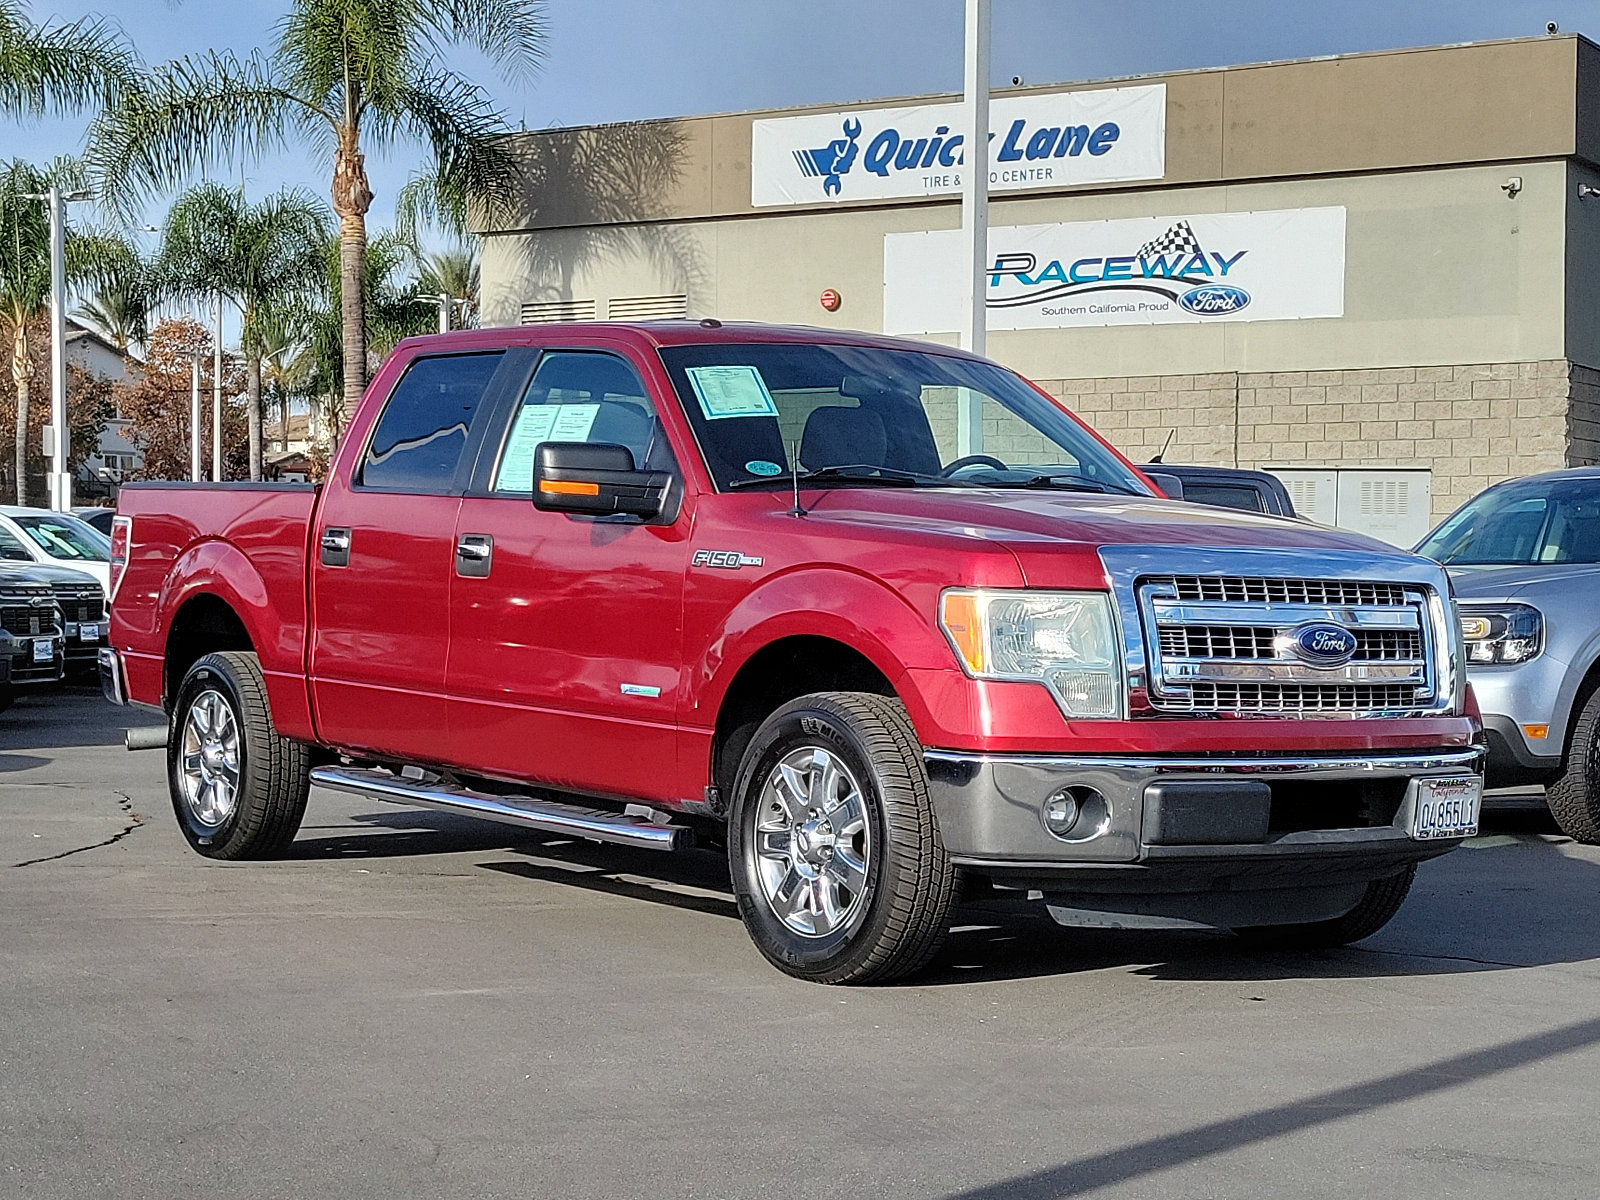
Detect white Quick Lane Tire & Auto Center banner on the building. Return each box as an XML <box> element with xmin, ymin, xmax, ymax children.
<box><xmin>750</xmin><ymin>83</ymin><xmax>1166</xmax><ymax>208</ymax></box>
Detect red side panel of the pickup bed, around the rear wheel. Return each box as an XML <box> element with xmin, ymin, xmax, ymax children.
<box><xmin>112</xmin><ymin>483</ymin><xmax>317</xmax><ymax>739</ymax></box>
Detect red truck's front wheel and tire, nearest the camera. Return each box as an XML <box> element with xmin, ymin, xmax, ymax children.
<box><xmin>728</xmin><ymin>691</ymin><xmax>960</xmax><ymax>984</ymax></box>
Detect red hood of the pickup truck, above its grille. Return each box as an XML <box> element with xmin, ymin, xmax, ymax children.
<box><xmin>808</xmin><ymin>488</ymin><xmax>1410</xmax><ymax>586</ymax></box>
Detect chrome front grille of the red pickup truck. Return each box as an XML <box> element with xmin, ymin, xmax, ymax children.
<box><xmin>1136</xmin><ymin>574</ymin><xmax>1440</xmax><ymax>717</ymax></box>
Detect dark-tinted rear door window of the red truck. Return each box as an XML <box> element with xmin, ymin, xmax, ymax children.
<box><xmin>362</xmin><ymin>354</ymin><xmax>501</xmax><ymax>491</ymax></box>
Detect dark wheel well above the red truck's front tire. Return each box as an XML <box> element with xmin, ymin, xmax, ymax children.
<box><xmin>710</xmin><ymin>637</ymin><xmax>894</xmax><ymax>800</ymax></box>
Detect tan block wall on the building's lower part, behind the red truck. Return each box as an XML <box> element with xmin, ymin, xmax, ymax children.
<box><xmin>1040</xmin><ymin>358</ymin><xmax>1574</xmax><ymax>518</ymax></box>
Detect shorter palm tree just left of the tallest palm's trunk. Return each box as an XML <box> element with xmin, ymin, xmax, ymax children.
<box><xmin>155</xmin><ymin>184</ymin><xmax>331</xmax><ymax>480</ymax></box>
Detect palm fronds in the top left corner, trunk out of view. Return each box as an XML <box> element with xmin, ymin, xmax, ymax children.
<box><xmin>0</xmin><ymin>0</ymin><xmax>136</xmax><ymax>117</ymax></box>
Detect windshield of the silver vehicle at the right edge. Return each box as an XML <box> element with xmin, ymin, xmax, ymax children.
<box><xmin>1416</xmin><ymin>478</ymin><xmax>1600</xmax><ymax>566</ymax></box>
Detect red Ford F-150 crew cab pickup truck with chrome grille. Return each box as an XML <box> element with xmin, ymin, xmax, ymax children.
<box><xmin>101</xmin><ymin>320</ymin><xmax>1482</xmax><ymax>982</ymax></box>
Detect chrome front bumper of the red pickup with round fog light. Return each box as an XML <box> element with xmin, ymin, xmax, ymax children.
<box><xmin>925</xmin><ymin>747</ymin><xmax>1483</xmax><ymax>888</ymax></box>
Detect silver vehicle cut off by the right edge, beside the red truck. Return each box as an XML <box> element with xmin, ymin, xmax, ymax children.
<box><xmin>1416</xmin><ymin>467</ymin><xmax>1600</xmax><ymax>845</ymax></box>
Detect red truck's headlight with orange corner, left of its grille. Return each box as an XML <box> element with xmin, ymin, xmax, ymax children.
<box><xmin>939</xmin><ymin>587</ymin><xmax>1123</xmax><ymax>718</ymax></box>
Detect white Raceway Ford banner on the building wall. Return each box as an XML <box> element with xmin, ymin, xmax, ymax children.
<box><xmin>883</xmin><ymin>208</ymin><xmax>1344</xmax><ymax>333</ymax></box>
